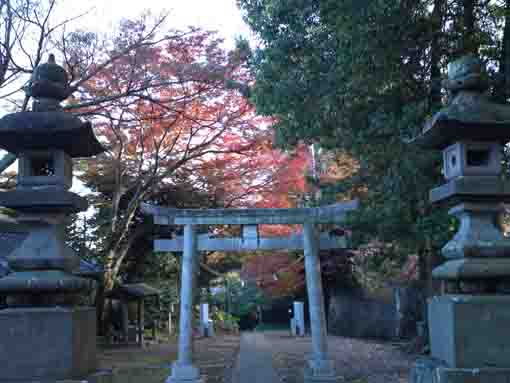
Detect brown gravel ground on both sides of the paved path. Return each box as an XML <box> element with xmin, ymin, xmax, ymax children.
<box><xmin>99</xmin><ymin>331</ymin><xmax>416</xmax><ymax>383</ymax></box>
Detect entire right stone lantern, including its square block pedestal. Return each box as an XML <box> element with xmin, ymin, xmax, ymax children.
<box><xmin>411</xmin><ymin>56</ymin><xmax>510</xmax><ymax>383</ymax></box>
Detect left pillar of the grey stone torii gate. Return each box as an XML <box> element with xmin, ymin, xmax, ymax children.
<box><xmin>167</xmin><ymin>224</ymin><xmax>203</xmax><ymax>383</ymax></box>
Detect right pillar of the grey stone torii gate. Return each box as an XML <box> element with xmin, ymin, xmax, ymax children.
<box><xmin>302</xmin><ymin>223</ymin><xmax>337</xmax><ymax>383</ymax></box>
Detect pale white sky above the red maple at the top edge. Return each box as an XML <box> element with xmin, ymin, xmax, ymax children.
<box><xmin>57</xmin><ymin>0</ymin><xmax>250</xmax><ymax>47</ymax></box>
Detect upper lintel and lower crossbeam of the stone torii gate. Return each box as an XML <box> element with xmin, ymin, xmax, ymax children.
<box><xmin>142</xmin><ymin>200</ymin><xmax>358</xmax><ymax>252</ymax></box>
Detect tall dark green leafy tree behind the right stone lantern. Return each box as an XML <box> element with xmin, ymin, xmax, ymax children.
<box><xmin>238</xmin><ymin>0</ymin><xmax>510</xmax><ymax>286</ymax></box>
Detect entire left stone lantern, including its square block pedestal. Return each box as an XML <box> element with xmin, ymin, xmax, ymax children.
<box><xmin>0</xmin><ymin>55</ymin><xmax>103</xmax><ymax>382</ymax></box>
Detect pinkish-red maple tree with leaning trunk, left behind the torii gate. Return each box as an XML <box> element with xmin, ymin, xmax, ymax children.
<box><xmin>63</xmin><ymin>19</ymin><xmax>268</xmax><ymax>289</ymax></box>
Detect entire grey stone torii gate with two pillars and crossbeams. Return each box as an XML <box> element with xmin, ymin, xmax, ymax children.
<box><xmin>142</xmin><ymin>201</ymin><xmax>358</xmax><ymax>383</ymax></box>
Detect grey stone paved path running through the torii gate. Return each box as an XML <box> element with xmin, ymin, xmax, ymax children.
<box><xmin>232</xmin><ymin>332</ymin><xmax>279</xmax><ymax>383</ymax></box>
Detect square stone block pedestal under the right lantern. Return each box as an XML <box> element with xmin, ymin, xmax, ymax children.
<box><xmin>410</xmin><ymin>295</ymin><xmax>510</xmax><ymax>383</ymax></box>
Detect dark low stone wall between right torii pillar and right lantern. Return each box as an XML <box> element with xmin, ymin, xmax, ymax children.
<box><xmin>328</xmin><ymin>286</ymin><xmax>421</xmax><ymax>339</ymax></box>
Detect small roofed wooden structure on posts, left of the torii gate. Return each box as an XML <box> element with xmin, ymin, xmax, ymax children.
<box><xmin>107</xmin><ymin>283</ymin><xmax>161</xmax><ymax>347</ymax></box>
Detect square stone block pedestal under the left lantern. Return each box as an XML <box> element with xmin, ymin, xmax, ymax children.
<box><xmin>0</xmin><ymin>307</ymin><xmax>96</xmax><ymax>383</ymax></box>
